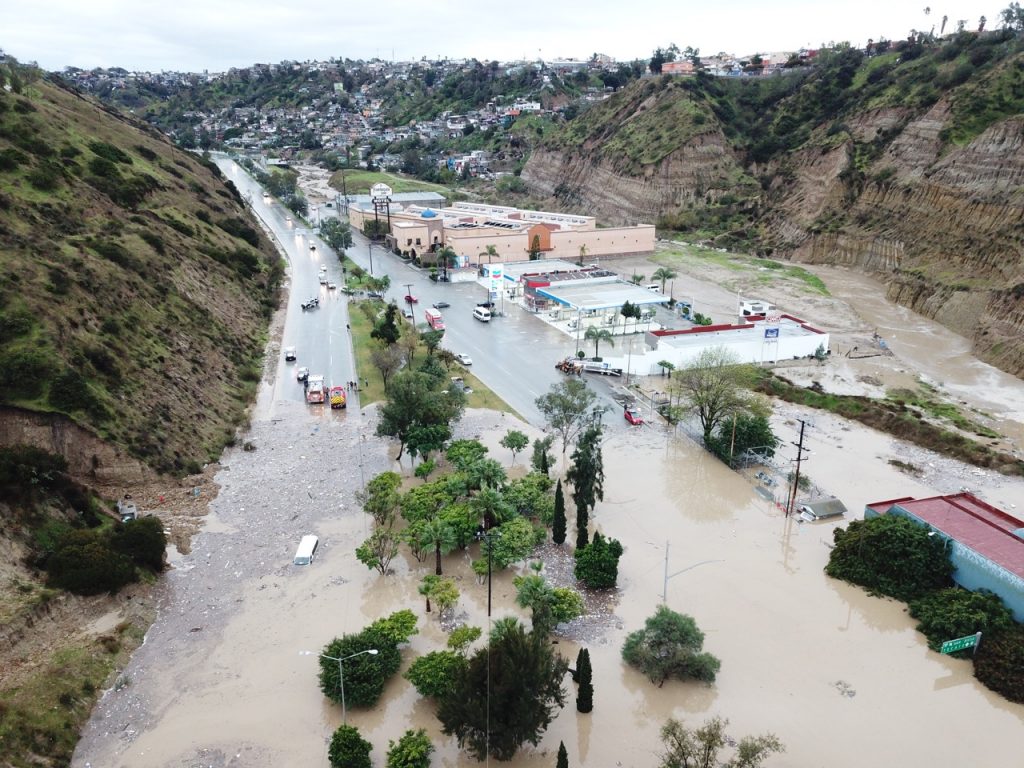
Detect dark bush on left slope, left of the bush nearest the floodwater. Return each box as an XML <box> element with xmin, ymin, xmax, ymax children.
<box><xmin>46</xmin><ymin>530</ymin><xmax>135</xmax><ymax>595</ymax></box>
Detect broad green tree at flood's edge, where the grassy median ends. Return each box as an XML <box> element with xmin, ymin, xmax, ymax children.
<box><xmin>377</xmin><ymin>371</ymin><xmax>466</xmax><ymax>461</ymax></box>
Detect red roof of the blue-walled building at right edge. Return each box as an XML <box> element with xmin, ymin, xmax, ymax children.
<box><xmin>867</xmin><ymin>494</ymin><xmax>1024</xmax><ymax>579</ymax></box>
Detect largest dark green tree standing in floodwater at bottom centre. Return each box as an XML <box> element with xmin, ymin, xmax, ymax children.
<box><xmin>437</xmin><ymin>620</ymin><xmax>568</xmax><ymax>760</ymax></box>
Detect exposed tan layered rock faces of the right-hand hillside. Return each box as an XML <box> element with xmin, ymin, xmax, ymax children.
<box><xmin>522</xmin><ymin>51</ymin><xmax>1024</xmax><ymax>376</ymax></box>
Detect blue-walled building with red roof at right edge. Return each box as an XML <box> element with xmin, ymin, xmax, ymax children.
<box><xmin>864</xmin><ymin>493</ymin><xmax>1024</xmax><ymax>626</ymax></box>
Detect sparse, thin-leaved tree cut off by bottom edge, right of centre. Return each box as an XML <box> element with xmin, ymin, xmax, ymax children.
<box><xmin>660</xmin><ymin>717</ymin><xmax>785</xmax><ymax>768</ymax></box>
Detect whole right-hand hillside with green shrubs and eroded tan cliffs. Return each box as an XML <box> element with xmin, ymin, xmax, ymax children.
<box><xmin>522</xmin><ymin>30</ymin><xmax>1024</xmax><ymax>376</ymax></box>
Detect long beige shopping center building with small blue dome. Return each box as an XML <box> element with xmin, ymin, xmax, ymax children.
<box><xmin>348</xmin><ymin>203</ymin><xmax>654</xmax><ymax>266</ymax></box>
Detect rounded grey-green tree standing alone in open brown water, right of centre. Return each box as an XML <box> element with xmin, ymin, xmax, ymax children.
<box><xmin>623</xmin><ymin>605</ymin><xmax>721</xmax><ymax>688</ymax></box>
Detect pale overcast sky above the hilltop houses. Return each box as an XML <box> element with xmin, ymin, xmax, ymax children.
<box><xmin>0</xmin><ymin>0</ymin><xmax>1009</xmax><ymax>72</ymax></box>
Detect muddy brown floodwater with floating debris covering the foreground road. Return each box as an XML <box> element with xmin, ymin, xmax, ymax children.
<box><xmin>74</xmin><ymin>402</ymin><xmax>1024</xmax><ymax>768</ymax></box>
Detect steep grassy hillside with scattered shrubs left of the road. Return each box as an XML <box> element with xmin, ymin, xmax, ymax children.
<box><xmin>0</xmin><ymin>70</ymin><xmax>283</xmax><ymax>472</ymax></box>
